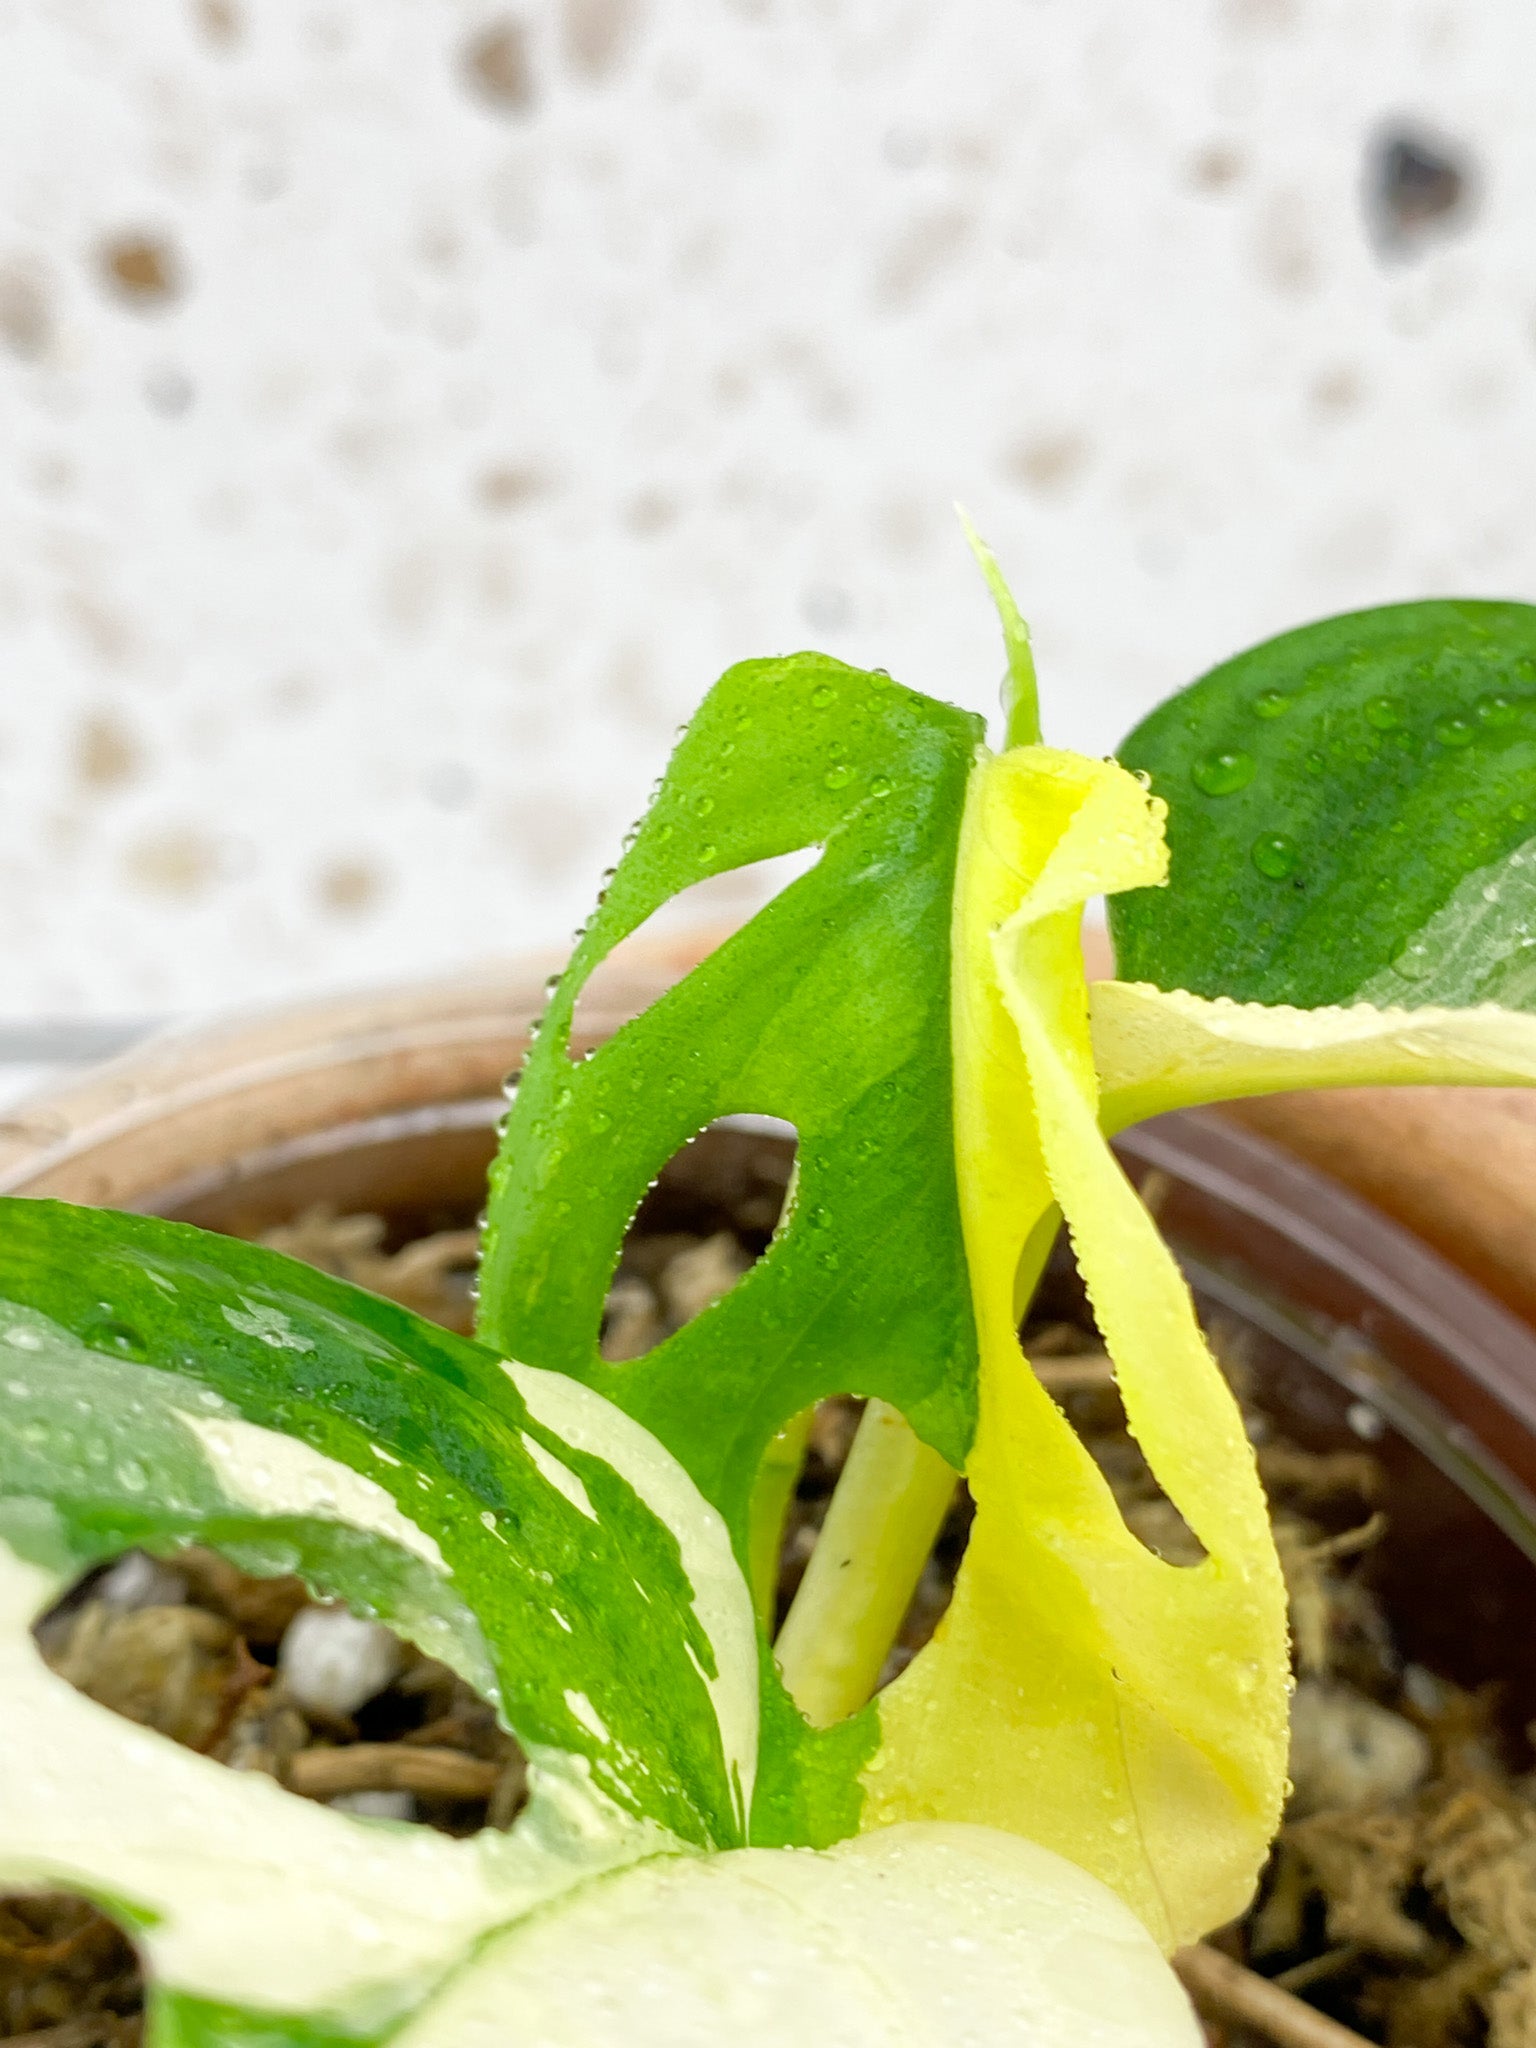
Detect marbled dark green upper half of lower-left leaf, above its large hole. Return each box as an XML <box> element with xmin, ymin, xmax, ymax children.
<box><xmin>0</xmin><ymin>1200</ymin><xmax>758</xmax><ymax>1845</ymax></box>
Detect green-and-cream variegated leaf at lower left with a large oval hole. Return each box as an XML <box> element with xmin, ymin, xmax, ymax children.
<box><xmin>0</xmin><ymin>1200</ymin><xmax>758</xmax><ymax>2042</ymax></box>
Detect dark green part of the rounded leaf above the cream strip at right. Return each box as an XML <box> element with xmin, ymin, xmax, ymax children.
<box><xmin>1110</xmin><ymin>600</ymin><xmax>1536</xmax><ymax>1008</ymax></box>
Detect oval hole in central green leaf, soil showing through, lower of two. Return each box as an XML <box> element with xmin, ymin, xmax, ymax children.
<box><xmin>600</xmin><ymin>1116</ymin><xmax>797</xmax><ymax>1364</ymax></box>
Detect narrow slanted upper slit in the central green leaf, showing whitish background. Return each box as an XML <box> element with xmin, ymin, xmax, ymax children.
<box><xmin>565</xmin><ymin>846</ymin><xmax>821</xmax><ymax>1065</ymax></box>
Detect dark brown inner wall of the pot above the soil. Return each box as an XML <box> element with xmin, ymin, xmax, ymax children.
<box><xmin>156</xmin><ymin>1100</ymin><xmax>1536</xmax><ymax>1745</ymax></box>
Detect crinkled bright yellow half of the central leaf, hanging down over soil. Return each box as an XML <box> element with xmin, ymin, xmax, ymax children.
<box><xmin>866</xmin><ymin>748</ymin><xmax>1288</xmax><ymax>1948</ymax></box>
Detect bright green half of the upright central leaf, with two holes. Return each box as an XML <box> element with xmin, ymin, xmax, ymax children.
<box><xmin>479</xmin><ymin>653</ymin><xmax>981</xmax><ymax>1523</ymax></box>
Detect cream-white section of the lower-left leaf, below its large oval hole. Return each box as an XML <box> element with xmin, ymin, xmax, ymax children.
<box><xmin>0</xmin><ymin>1540</ymin><xmax>672</xmax><ymax>2048</ymax></box>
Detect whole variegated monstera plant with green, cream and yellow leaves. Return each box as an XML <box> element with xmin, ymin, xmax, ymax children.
<box><xmin>0</xmin><ymin>551</ymin><xmax>1536</xmax><ymax>2048</ymax></box>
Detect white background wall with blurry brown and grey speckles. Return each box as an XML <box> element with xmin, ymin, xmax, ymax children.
<box><xmin>0</xmin><ymin>0</ymin><xmax>1536</xmax><ymax>1018</ymax></box>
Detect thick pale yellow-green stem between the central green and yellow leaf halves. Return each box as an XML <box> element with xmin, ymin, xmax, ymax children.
<box><xmin>774</xmin><ymin>1401</ymin><xmax>956</xmax><ymax>1729</ymax></box>
